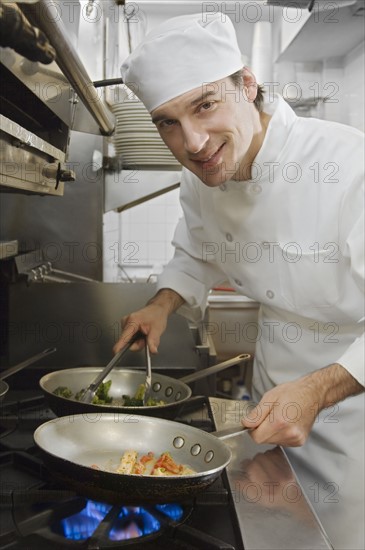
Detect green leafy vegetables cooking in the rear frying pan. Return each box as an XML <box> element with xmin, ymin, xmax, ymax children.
<box><xmin>53</xmin><ymin>380</ymin><xmax>166</xmax><ymax>407</ymax></box>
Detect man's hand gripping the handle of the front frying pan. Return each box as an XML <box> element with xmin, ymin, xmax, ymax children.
<box><xmin>242</xmin><ymin>363</ymin><xmax>364</xmax><ymax>447</ymax></box>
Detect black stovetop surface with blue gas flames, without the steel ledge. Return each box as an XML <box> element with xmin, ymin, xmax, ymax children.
<box><xmin>0</xmin><ymin>391</ymin><xmax>243</xmax><ymax>550</ymax></box>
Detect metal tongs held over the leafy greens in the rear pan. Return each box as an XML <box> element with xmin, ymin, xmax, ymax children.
<box><xmin>79</xmin><ymin>331</ymin><xmax>152</xmax><ymax>405</ymax></box>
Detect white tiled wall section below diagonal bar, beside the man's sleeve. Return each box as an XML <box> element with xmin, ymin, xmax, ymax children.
<box><xmin>104</xmin><ymin>189</ymin><xmax>182</xmax><ymax>282</ymax></box>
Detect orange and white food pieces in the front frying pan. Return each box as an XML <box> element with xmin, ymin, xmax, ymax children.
<box><xmin>91</xmin><ymin>450</ymin><xmax>196</xmax><ymax>476</ymax></box>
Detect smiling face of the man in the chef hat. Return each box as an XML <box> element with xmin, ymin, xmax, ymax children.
<box><xmin>152</xmin><ymin>73</ymin><xmax>262</xmax><ymax>187</ymax></box>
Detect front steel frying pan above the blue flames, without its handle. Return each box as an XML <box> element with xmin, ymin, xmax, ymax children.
<box><xmin>34</xmin><ymin>413</ymin><xmax>242</xmax><ymax>504</ymax></box>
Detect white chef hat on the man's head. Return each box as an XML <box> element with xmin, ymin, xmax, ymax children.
<box><xmin>121</xmin><ymin>13</ymin><xmax>243</xmax><ymax>112</ymax></box>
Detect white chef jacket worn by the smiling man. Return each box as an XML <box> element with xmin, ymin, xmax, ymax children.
<box><xmin>158</xmin><ymin>96</ymin><xmax>365</xmax><ymax>550</ymax></box>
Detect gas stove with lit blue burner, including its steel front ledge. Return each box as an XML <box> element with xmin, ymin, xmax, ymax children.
<box><xmin>0</xmin><ymin>390</ymin><xmax>331</xmax><ymax>550</ymax></box>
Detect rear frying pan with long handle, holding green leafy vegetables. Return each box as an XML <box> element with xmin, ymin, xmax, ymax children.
<box><xmin>39</xmin><ymin>353</ymin><xmax>251</xmax><ymax>419</ymax></box>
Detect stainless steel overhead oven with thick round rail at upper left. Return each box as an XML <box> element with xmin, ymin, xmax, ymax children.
<box><xmin>0</xmin><ymin>0</ymin><xmax>115</xmax><ymax>195</ymax></box>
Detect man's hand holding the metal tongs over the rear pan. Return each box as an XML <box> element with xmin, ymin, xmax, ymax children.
<box><xmin>113</xmin><ymin>288</ymin><xmax>184</xmax><ymax>353</ymax></box>
